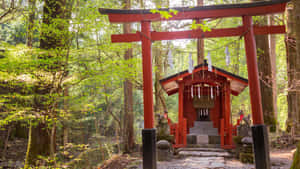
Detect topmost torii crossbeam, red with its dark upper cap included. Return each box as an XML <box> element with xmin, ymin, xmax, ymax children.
<box><xmin>99</xmin><ymin>1</ymin><xmax>287</xmax><ymax>23</ymax></box>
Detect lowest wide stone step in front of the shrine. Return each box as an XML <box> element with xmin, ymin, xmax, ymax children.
<box><xmin>178</xmin><ymin>151</ymin><xmax>232</xmax><ymax>158</ymax></box>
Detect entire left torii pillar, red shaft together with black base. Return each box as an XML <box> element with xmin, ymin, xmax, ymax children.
<box><xmin>140</xmin><ymin>21</ymin><xmax>156</xmax><ymax>169</ymax></box>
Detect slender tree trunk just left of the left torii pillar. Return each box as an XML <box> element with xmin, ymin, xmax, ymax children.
<box><xmin>123</xmin><ymin>0</ymin><xmax>134</xmax><ymax>153</ymax></box>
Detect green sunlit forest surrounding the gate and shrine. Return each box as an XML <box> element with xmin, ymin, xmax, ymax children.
<box><xmin>0</xmin><ymin>0</ymin><xmax>300</xmax><ymax>169</ymax></box>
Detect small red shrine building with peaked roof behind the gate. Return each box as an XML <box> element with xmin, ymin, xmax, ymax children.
<box><xmin>160</xmin><ymin>62</ymin><xmax>248</xmax><ymax>149</ymax></box>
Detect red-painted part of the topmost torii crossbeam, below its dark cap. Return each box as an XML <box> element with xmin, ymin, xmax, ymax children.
<box><xmin>108</xmin><ymin>3</ymin><xmax>286</xmax><ymax>23</ymax></box>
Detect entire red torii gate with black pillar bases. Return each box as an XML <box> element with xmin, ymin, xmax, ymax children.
<box><xmin>99</xmin><ymin>0</ymin><xmax>290</xmax><ymax>169</ymax></box>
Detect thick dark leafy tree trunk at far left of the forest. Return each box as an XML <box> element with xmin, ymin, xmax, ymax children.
<box><xmin>28</xmin><ymin>0</ymin><xmax>74</xmax><ymax>164</ymax></box>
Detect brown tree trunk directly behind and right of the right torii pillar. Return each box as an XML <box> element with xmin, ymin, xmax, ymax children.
<box><xmin>252</xmin><ymin>0</ymin><xmax>277</xmax><ymax>132</ymax></box>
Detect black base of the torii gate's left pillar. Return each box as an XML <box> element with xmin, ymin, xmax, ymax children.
<box><xmin>142</xmin><ymin>129</ymin><xmax>156</xmax><ymax>169</ymax></box>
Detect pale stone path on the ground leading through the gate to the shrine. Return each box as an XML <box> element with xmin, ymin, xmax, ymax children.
<box><xmin>128</xmin><ymin>148</ymin><xmax>292</xmax><ymax>169</ymax></box>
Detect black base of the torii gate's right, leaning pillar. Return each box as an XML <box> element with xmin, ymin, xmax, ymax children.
<box><xmin>252</xmin><ymin>125</ymin><xmax>270</xmax><ymax>169</ymax></box>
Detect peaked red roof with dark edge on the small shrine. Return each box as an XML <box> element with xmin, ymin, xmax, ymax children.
<box><xmin>160</xmin><ymin>61</ymin><xmax>248</xmax><ymax>96</ymax></box>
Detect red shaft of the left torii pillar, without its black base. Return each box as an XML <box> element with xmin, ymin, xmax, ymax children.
<box><xmin>141</xmin><ymin>22</ymin><xmax>154</xmax><ymax>128</ymax></box>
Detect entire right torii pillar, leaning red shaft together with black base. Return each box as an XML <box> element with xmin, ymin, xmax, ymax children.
<box><xmin>243</xmin><ymin>16</ymin><xmax>270</xmax><ymax>169</ymax></box>
